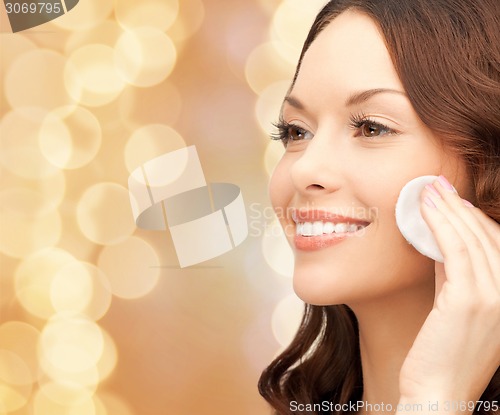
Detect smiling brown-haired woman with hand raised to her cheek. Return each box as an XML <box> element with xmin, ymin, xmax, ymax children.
<box><xmin>259</xmin><ymin>0</ymin><xmax>500</xmax><ymax>415</ymax></box>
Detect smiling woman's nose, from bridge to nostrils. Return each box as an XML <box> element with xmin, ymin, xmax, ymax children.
<box><xmin>290</xmin><ymin>134</ymin><xmax>342</xmax><ymax>194</ymax></box>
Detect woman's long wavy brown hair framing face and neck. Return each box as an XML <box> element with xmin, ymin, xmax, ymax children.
<box><xmin>259</xmin><ymin>0</ymin><xmax>500</xmax><ymax>415</ymax></box>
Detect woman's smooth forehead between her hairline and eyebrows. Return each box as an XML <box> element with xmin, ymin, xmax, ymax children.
<box><xmin>293</xmin><ymin>11</ymin><xmax>403</xmax><ymax>101</ymax></box>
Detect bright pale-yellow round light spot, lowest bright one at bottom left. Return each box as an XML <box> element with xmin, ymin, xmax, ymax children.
<box><xmin>39</xmin><ymin>313</ymin><xmax>104</xmax><ymax>373</ymax></box>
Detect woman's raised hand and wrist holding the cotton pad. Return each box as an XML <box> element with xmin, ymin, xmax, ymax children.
<box><xmin>400</xmin><ymin>176</ymin><xmax>500</xmax><ymax>415</ymax></box>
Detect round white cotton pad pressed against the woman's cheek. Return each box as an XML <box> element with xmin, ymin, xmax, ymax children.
<box><xmin>396</xmin><ymin>176</ymin><xmax>444</xmax><ymax>262</ymax></box>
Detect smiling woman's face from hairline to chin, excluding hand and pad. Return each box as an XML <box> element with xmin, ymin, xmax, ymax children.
<box><xmin>270</xmin><ymin>12</ymin><xmax>468</xmax><ymax>305</ymax></box>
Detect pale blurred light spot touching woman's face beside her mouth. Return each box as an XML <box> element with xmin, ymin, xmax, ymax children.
<box><xmin>262</xmin><ymin>221</ymin><xmax>294</xmax><ymax>277</ymax></box>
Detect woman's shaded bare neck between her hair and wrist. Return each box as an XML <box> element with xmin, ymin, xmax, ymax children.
<box><xmin>350</xmin><ymin>284</ymin><xmax>434</xmax><ymax>414</ymax></box>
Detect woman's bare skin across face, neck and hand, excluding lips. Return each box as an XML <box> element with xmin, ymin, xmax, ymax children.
<box><xmin>270</xmin><ymin>11</ymin><xmax>500</xmax><ymax>415</ymax></box>
